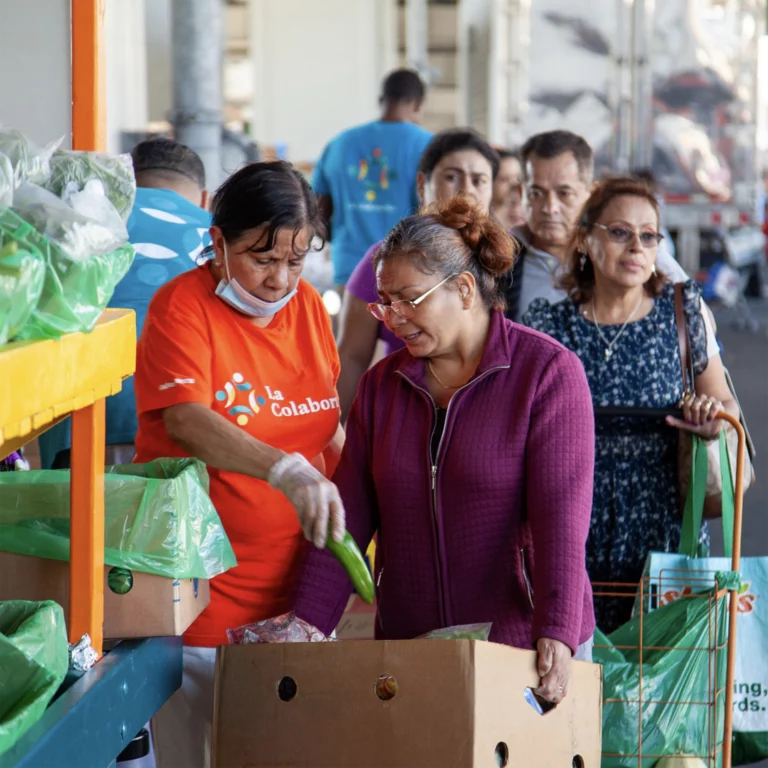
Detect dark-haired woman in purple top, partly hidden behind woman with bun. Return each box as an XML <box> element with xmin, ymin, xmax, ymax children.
<box><xmin>339</xmin><ymin>128</ymin><xmax>500</xmax><ymax>419</ymax></box>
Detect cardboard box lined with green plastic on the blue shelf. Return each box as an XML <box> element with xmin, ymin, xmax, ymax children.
<box><xmin>0</xmin><ymin>552</ymin><xmax>211</xmax><ymax>640</ymax></box>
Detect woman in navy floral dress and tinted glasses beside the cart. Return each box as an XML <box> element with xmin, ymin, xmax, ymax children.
<box><xmin>523</xmin><ymin>178</ymin><xmax>737</xmax><ymax>632</ymax></box>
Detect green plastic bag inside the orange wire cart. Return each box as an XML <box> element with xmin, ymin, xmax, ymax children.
<box><xmin>593</xmin><ymin>572</ymin><xmax>739</xmax><ymax>768</ymax></box>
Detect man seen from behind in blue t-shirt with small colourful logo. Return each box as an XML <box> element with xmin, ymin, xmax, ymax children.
<box><xmin>312</xmin><ymin>69</ymin><xmax>431</xmax><ymax>288</ymax></box>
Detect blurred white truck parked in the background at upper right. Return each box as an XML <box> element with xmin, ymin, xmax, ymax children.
<box><xmin>472</xmin><ymin>0</ymin><xmax>765</xmax><ymax>292</ymax></box>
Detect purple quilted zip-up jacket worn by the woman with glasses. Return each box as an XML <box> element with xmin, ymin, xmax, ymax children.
<box><xmin>295</xmin><ymin>312</ymin><xmax>595</xmax><ymax>652</ymax></box>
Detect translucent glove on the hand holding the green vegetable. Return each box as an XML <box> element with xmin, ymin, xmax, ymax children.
<box><xmin>267</xmin><ymin>453</ymin><xmax>345</xmax><ymax>549</ymax></box>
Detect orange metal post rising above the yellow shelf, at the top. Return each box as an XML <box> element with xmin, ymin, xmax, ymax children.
<box><xmin>72</xmin><ymin>0</ymin><xmax>107</xmax><ymax>150</ymax></box>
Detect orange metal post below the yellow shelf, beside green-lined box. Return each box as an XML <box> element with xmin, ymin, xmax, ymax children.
<box><xmin>69</xmin><ymin>400</ymin><xmax>105</xmax><ymax>656</ymax></box>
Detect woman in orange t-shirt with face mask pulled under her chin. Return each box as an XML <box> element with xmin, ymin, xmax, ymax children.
<box><xmin>135</xmin><ymin>163</ymin><xmax>344</xmax><ymax>768</ymax></box>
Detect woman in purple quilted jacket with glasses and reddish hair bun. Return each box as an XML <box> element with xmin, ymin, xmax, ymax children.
<box><xmin>295</xmin><ymin>197</ymin><xmax>594</xmax><ymax>702</ymax></box>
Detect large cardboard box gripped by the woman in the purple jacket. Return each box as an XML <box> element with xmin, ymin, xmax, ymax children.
<box><xmin>213</xmin><ymin>640</ymin><xmax>602</xmax><ymax>768</ymax></box>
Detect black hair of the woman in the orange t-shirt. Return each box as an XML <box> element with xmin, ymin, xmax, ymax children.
<box><xmin>211</xmin><ymin>160</ymin><xmax>325</xmax><ymax>256</ymax></box>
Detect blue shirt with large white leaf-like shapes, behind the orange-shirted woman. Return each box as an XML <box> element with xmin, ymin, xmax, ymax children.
<box><xmin>39</xmin><ymin>187</ymin><xmax>211</xmax><ymax>469</ymax></box>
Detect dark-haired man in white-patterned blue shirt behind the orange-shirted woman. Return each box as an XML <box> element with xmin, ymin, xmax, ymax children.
<box><xmin>39</xmin><ymin>138</ymin><xmax>211</xmax><ymax>469</ymax></box>
